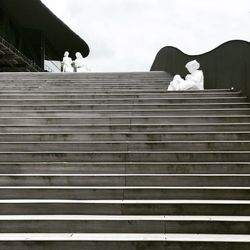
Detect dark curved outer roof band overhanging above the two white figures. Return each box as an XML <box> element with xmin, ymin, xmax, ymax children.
<box><xmin>0</xmin><ymin>0</ymin><xmax>89</xmax><ymax>60</ymax></box>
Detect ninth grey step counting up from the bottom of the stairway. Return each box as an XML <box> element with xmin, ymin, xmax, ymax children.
<box><xmin>0</xmin><ymin>131</ymin><xmax>250</xmax><ymax>142</ymax></box>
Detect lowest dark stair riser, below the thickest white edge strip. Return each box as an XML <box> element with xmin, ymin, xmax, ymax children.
<box><xmin>0</xmin><ymin>242</ymin><xmax>246</xmax><ymax>250</ymax></box>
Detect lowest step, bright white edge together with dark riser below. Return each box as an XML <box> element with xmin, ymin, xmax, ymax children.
<box><xmin>0</xmin><ymin>240</ymin><xmax>249</xmax><ymax>250</ymax></box>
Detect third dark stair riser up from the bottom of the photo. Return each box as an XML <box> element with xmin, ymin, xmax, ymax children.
<box><xmin>0</xmin><ymin>202</ymin><xmax>250</xmax><ymax>216</ymax></box>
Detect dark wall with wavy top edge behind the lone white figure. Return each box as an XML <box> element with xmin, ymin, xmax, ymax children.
<box><xmin>151</xmin><ymin>40</ymin><xmax>250</xmax><ymax>97</ymax></box>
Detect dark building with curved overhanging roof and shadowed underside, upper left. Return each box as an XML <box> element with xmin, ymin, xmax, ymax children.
<box><xmin>0</xmin><ymin>0</ymin><xmax>89</xmax><ymax>68</ymax></box>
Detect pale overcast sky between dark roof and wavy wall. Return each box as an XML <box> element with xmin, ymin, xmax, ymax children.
<box><xmin>42</xmin><ymin>0</ymin><xmax>250</xmax><ymax>71</ymax></box>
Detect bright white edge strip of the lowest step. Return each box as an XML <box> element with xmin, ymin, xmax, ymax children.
<box><xmin>0</xmin><ymin>233</ymin><xmax>250</xmax><ymax>243</ymax></box>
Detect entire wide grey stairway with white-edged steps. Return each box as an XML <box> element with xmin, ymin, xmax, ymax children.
<box><xmin>0</xmin><ymin>72</ymin><xmax>250</xmax><ymax>250</ymax></box>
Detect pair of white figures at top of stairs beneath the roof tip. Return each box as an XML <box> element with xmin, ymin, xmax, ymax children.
<box><xmin>62</xmin><ymin>51</ymin><xmax>90</xmax><ymax>73</ymax></box>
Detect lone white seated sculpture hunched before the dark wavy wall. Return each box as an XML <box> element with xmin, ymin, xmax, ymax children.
<box><xmin>168</xmin><ymin>60</ymin><xmax>204</xmax><ymax>91</ymax></box>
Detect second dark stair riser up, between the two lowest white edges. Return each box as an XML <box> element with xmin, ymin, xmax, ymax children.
<box><xmin>0</xmin><ymin>220</ymin><xmax>250</xmax><ymax>234</ymax></box>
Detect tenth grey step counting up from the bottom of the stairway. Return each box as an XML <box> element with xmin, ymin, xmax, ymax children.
<box><xmin>0</xmin><ymin>121</ymin><xmax>250</xmax><ymax>133</ymax></box>
